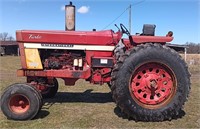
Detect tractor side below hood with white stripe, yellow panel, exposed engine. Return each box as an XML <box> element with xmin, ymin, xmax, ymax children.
<box><xmin>17</xmin><ymin>42</ymin><xmax>114</xmax><ymax>85</ymax></box>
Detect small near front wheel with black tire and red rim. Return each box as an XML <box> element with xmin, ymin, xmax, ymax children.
<box><xmin>1</xmin><ymin>84</ymin><xmax>42</xmax><ymax>120</ymax></box>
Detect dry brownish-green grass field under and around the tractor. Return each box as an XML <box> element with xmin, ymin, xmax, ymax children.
<box><xmin>0</xmin><ymin>55</ymin><xmax>200</xmax><ymax>129</ymax></box>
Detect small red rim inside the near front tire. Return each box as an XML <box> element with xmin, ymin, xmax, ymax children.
<box><xmin>9</xmin><ymin>94</ymin><xmax>30</xmax><ymax>114</ymax></box>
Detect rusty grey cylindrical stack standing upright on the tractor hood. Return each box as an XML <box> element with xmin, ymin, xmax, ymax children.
<box><xmin>65</xmin><ymin>1</ymin><xmax>76</xmax><ymax>31</ymax></box>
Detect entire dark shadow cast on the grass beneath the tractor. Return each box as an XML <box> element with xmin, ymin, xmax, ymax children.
<box><xmin>34</xmin><ymin>89</ymin><xmax>185</xmax><ymax>122</ymax></box>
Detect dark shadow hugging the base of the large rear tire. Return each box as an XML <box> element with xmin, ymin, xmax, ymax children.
<box><xmin>114</xmin><ymin>106</ymin><xmax>185</xmax><ymax>122</ymax></box>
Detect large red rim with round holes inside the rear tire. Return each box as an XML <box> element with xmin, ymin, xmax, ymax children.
<box><xmin>129</xmin><ymin>62</ymin><xmax>176</xmax><ymax>109</ymax></box>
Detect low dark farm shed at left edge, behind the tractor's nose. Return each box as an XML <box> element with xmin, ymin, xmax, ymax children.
<box><xmin>0</xmin><ymin>41</ymin><xmax>19</xmax><ymax>56</ymax></box>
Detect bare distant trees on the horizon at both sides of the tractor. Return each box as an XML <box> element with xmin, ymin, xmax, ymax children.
<box><xmin>0</xmin><ymin>32</ymin><xmax>200</xmax><ymax>54</ymax></box>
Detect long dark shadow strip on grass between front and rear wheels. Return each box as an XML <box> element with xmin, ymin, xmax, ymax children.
<box><xmin>43</xmin><ymin>89</ymin><xmax>113</xmax><ymax>109</ymax></box>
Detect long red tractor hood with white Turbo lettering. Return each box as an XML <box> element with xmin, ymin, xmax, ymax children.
<box><xmin>16</xmin><ymin>30</ymin><xmax>122</xmax><ymax>45</ymax></box>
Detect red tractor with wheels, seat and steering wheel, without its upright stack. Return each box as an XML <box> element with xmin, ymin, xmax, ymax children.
<box><xmin>1</xmin><ymin>24</ymin><xmax>190</xmax><ymax>121</ymax></box>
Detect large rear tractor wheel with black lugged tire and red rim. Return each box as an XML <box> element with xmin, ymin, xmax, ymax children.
<box><xmin>112</xmin><ymin>43</ymin><xmax>190</xmax><ymax>121</ymax></box>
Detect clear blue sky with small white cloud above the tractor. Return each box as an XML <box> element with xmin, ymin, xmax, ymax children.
<box><xmin>0</xmin><ymin>0</ymin><xmax>200</xmax><ymax>44</ymax></box>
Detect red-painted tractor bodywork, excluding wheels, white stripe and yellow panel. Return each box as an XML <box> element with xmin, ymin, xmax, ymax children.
<box><xmin>16</xmin><ymin>27</ymin><xmax>173</xmax><ymax>85</ymax></box>
